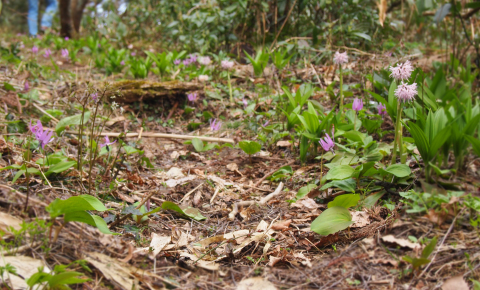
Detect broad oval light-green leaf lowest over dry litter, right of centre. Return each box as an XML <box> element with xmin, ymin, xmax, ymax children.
<box><xmin>310</xmin><ymin>206</ymin><xmax>354</xmax><ymax>236</ymax></box>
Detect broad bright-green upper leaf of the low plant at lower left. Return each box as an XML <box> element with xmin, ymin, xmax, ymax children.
<box><xmin>45</xmin><ymin>194</ymin><xmax>107</xmax><ymax>218</ymax></box>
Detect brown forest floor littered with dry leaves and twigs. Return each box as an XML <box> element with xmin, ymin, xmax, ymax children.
<box><xmin>0</xmin><ymin>41</ymin><xmax>480</xmax><ymax>290</ymax></box>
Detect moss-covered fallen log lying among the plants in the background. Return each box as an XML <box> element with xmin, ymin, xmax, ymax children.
<box><xmin>106</xmin><ymin>80</ymin><xmax>203</xmax><ymax>103</ymax></box>
